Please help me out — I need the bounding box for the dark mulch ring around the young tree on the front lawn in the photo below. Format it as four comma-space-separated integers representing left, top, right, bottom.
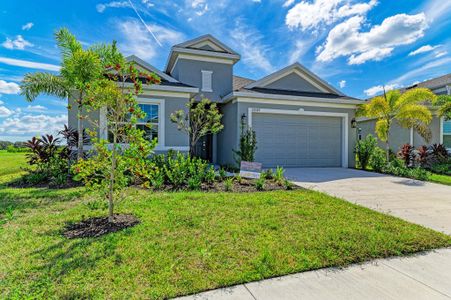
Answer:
63, 215, 139, 239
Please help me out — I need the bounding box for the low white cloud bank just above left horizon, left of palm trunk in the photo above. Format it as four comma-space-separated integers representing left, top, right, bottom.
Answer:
0, 114, 67, 136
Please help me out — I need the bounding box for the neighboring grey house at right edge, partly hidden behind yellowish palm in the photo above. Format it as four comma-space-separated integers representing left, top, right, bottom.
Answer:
357, 74, 451, 152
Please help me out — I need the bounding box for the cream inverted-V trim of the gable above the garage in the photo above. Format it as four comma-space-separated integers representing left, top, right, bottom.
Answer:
245, 62, 345, 96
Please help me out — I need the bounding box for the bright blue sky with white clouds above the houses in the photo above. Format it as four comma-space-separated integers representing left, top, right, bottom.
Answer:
0, 0, 451, 141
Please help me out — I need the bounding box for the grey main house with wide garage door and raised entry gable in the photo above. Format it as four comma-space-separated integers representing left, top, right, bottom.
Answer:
69, 35, 361, 167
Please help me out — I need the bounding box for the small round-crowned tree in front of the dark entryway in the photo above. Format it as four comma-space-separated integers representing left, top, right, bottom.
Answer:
171, 98, 224, 157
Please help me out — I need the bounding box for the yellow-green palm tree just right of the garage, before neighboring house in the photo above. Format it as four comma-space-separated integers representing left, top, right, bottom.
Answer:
357, 88, 437, 161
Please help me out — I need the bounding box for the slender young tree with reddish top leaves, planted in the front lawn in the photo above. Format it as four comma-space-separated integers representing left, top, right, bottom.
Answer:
73, 43, 160, 222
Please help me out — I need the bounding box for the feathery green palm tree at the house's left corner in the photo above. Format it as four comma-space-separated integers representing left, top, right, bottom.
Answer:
20, 28, 103, 160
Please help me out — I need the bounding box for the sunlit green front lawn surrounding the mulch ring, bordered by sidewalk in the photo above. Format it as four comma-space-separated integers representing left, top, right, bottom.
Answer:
0, 154, 451, 299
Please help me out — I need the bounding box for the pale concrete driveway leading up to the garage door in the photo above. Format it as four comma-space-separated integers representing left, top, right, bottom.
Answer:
285, 168, 451, 234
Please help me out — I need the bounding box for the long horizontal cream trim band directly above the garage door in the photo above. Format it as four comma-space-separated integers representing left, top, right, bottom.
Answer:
232, 97, 362, 109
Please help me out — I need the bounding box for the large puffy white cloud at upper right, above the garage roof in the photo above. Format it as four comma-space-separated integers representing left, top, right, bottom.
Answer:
317, 13, 428, 64
